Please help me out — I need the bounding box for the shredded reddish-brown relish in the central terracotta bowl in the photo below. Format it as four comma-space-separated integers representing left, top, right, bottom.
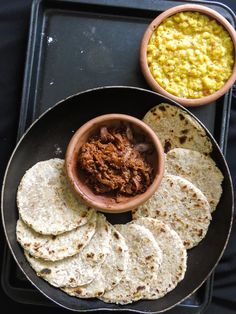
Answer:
78, 126, 153, 197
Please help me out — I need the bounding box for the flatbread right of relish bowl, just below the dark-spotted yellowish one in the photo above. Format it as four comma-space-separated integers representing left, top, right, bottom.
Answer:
166, 148, 224, 212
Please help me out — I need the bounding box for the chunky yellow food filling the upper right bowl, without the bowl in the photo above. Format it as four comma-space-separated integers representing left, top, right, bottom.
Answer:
147, 12, 234, 98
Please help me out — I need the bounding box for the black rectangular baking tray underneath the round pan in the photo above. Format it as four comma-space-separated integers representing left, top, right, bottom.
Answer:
1, 0, 236, 314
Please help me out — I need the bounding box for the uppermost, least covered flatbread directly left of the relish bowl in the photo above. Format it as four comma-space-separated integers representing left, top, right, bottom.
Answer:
17, 158, 94, 235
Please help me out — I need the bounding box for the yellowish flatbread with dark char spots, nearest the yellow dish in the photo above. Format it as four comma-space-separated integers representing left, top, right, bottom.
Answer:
143, 103, 212, 154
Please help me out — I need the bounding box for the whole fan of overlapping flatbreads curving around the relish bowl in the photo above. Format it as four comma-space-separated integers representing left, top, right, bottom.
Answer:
16, 104, 223, 304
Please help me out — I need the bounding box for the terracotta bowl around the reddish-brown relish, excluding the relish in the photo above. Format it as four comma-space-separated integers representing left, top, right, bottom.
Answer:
65, 114, 164, 213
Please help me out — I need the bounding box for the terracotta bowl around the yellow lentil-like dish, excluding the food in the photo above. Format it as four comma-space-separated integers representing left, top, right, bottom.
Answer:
140, 4, 236, 107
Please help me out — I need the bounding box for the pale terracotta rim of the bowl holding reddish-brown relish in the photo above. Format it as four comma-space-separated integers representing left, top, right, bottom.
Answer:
65, 113, 165, 213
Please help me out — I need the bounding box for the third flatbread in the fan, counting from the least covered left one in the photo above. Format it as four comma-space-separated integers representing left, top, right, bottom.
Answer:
25, 214, 110, 287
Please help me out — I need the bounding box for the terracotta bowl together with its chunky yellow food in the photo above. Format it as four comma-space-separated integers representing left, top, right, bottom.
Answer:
140, 4, 236, 106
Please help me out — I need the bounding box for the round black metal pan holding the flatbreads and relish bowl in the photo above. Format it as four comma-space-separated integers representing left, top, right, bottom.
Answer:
2, 87, 233, 313
